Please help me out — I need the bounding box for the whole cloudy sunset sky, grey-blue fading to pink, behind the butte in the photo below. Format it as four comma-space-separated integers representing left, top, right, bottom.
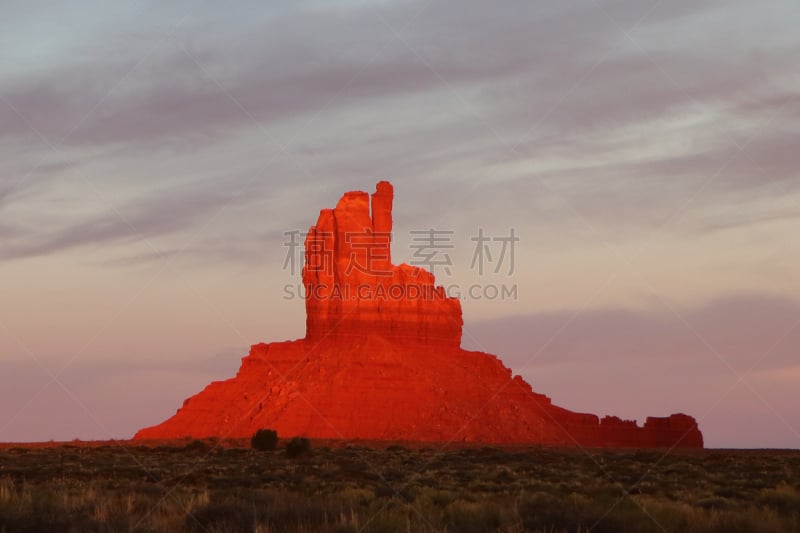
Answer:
0, 0, 800, 448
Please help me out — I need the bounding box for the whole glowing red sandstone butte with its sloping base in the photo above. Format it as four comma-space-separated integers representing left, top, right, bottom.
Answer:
134, 181, 703, 448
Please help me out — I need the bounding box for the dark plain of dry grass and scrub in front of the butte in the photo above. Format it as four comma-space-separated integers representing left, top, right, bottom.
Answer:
0, 442, 800, 533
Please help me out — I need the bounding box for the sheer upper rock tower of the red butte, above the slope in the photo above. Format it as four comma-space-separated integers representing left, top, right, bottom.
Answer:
303, 181, 463, 348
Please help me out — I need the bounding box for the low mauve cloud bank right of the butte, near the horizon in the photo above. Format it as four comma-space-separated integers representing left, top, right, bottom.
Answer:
465, 294, 800, 373
